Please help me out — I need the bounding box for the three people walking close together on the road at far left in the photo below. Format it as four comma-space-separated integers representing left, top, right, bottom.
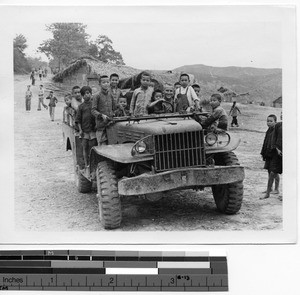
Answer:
25, 85, 58, 121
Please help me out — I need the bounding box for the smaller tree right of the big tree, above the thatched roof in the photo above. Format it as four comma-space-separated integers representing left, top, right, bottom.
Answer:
88, 35, 125, 65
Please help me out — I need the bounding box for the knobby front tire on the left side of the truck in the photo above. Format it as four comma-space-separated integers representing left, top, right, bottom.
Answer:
96, 161, 122, 229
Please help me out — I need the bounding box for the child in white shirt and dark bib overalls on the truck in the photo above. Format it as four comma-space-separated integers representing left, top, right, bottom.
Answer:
174, 74, 200, 112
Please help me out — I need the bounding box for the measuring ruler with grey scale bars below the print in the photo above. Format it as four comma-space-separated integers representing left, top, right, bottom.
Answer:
0, 250, 228, 292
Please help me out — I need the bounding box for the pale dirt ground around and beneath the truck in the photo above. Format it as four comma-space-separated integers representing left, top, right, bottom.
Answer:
14, 76, 282, 232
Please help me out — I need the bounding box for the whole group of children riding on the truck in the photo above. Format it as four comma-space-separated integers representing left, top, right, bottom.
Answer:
64, 72, 234, 169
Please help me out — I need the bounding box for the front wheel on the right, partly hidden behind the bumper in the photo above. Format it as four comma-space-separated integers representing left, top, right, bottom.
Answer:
212, 152, 244, 214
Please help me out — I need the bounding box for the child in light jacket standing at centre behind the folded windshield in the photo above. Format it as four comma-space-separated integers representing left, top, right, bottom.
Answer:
130, 72, 153, 116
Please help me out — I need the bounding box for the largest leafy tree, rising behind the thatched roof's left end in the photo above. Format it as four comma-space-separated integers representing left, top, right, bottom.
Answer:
38, 23, 89, 69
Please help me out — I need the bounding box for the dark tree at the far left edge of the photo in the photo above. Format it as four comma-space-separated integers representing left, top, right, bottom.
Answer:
13, 34, 31, 74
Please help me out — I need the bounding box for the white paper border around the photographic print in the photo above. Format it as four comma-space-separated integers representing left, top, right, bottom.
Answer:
0, 5, 297, 244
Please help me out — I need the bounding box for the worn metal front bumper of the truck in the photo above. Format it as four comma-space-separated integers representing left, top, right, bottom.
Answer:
118, 166, 245, 196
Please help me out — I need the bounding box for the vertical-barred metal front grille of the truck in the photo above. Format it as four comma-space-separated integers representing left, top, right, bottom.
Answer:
154, 130, 205, 172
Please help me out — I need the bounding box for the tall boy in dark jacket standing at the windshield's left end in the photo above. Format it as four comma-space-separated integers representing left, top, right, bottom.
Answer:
92, 75, 116, 146
